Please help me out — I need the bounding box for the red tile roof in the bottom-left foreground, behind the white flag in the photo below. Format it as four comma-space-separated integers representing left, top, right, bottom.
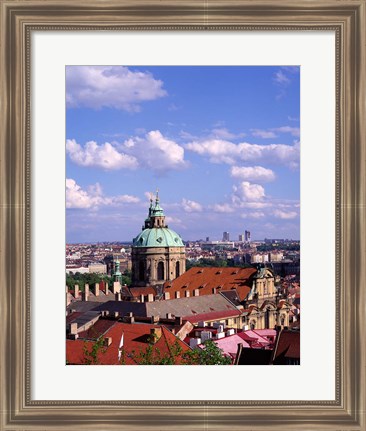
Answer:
66, 322, 190, 365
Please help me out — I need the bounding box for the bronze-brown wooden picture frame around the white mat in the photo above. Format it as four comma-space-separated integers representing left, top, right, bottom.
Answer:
0, 0, 366, 431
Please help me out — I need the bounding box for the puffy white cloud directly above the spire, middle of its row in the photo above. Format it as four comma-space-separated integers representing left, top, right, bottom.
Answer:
121, 130, 187, 172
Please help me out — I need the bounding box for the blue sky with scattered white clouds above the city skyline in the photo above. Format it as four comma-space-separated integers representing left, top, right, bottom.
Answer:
66, 66, 300, 243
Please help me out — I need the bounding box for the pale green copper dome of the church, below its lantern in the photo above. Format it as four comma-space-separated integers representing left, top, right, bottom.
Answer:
133, 227, 184, 247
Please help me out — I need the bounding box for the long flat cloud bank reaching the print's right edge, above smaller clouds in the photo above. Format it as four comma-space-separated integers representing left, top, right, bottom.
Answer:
185, 139, 300, 166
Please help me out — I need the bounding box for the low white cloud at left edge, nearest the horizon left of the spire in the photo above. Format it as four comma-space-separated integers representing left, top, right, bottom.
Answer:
66, 178, 140, 208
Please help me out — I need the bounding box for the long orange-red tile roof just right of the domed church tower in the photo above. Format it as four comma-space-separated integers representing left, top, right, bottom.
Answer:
164, 267, 257, 301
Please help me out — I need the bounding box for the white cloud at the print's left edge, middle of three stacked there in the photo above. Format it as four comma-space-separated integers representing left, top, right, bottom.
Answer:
66, 139, 138, 170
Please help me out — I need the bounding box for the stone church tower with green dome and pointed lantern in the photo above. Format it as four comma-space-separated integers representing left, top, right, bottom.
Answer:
132, 193, 186, 286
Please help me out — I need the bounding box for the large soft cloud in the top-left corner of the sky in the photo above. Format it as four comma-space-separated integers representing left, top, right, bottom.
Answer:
66, 66, 167, 112
